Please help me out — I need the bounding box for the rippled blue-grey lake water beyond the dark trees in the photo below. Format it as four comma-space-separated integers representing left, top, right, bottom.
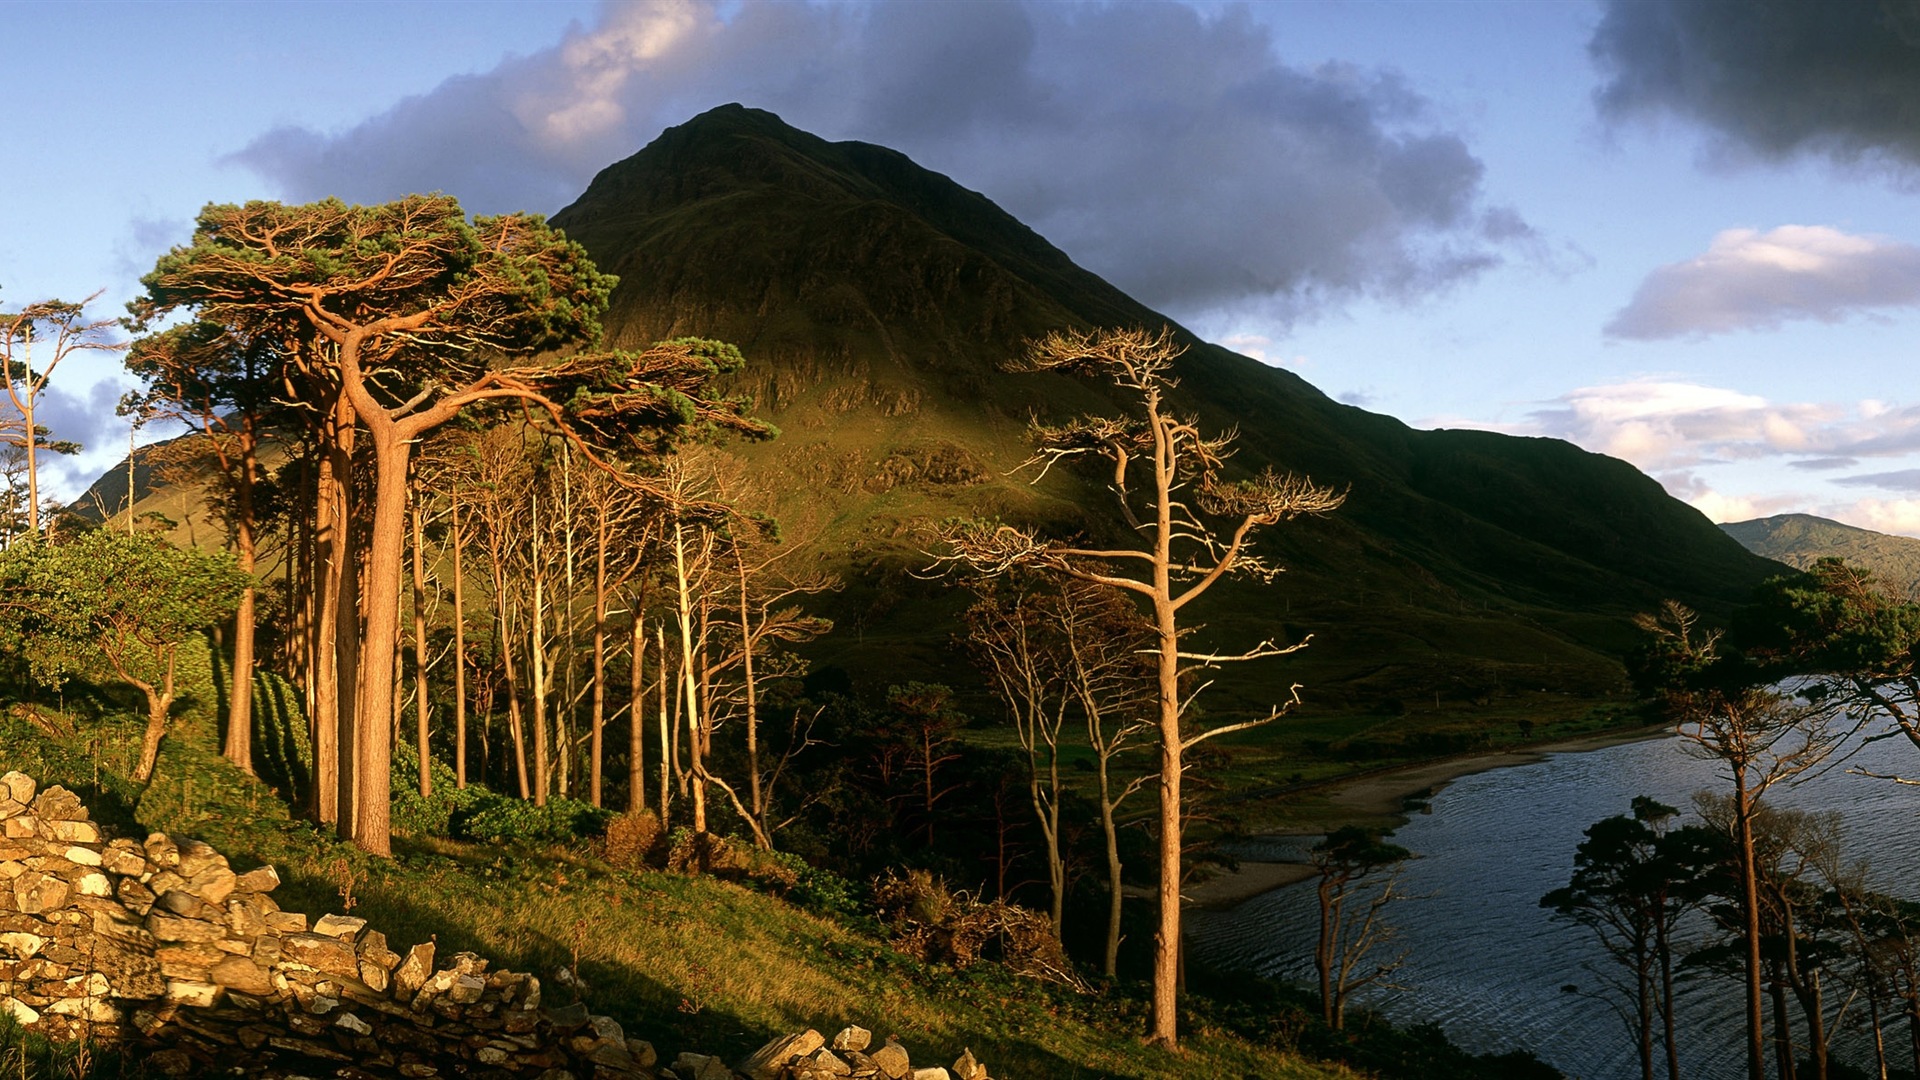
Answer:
1188, 722, 1920, 1080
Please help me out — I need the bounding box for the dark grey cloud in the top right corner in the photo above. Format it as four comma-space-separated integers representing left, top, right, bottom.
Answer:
1588, 0, 1920, 167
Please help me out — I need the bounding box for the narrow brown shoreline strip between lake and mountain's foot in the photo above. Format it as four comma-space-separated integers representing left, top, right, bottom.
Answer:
1183, 728, 1668, 909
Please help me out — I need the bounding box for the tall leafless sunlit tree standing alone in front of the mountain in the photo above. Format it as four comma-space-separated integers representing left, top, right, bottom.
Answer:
945, 331, 1344, 1047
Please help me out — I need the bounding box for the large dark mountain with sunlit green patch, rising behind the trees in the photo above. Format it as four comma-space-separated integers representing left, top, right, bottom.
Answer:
553, 106, 1780, 703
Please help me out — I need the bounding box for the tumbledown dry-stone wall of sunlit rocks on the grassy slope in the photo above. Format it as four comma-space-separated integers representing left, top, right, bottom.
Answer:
0, 773, 987, 1080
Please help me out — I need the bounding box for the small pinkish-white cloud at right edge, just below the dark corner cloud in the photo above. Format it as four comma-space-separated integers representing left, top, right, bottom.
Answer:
1605, 225, 1920, 340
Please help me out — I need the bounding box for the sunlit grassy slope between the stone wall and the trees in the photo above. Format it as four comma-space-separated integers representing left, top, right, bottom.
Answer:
0, 707, 1357, 1080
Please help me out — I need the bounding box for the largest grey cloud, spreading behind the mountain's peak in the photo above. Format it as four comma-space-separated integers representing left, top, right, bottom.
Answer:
234, 2, 1534, 317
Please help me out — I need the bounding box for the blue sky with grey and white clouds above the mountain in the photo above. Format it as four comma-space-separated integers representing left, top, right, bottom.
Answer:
0, 0, 1920, 536
